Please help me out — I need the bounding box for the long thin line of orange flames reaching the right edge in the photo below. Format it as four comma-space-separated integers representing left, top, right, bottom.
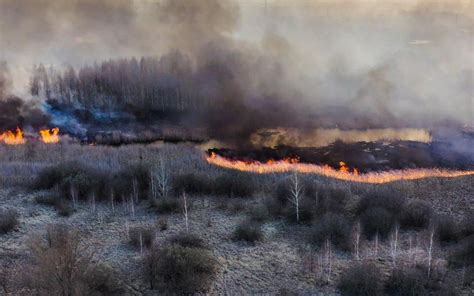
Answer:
207, 153, 474, 184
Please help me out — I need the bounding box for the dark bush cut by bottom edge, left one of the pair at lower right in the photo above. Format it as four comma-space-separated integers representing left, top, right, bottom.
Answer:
337, 263, 382, 296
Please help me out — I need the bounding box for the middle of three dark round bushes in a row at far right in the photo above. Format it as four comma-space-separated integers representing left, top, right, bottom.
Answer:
400, 200, 433, 229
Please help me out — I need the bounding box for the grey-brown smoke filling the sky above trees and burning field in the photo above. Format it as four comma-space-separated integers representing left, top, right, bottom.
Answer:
0, 0, 474, 140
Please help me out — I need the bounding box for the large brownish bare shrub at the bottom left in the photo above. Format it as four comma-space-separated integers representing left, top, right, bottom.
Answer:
28, 224, 123, 295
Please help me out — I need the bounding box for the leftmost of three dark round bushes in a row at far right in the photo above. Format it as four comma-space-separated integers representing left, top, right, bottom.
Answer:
361, 207, 395, 238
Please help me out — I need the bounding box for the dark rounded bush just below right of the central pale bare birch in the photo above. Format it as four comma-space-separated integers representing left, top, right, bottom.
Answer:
310, 213, 351, 250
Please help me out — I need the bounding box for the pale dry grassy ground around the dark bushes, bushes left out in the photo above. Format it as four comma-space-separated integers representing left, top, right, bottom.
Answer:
0, 144, 474, 295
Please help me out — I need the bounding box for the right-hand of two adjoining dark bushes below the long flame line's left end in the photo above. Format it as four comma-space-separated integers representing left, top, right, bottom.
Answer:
214, 173, 255, 197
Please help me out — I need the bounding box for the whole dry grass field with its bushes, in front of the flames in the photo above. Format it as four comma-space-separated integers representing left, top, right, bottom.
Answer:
0, 143, 474, 295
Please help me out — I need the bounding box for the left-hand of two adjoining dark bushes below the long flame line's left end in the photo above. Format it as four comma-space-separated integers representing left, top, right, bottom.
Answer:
172, 174, 212, 195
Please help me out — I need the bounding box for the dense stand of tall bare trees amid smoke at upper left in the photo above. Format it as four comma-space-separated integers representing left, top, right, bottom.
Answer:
30, 52, 210, 112
